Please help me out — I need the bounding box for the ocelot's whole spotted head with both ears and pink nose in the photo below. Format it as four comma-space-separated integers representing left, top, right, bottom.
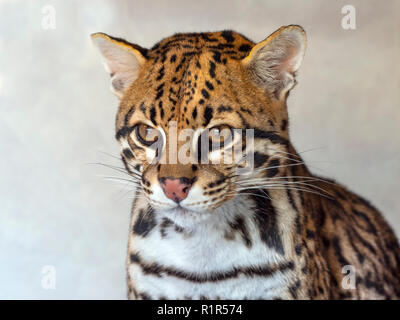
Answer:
92, 25, 306, 225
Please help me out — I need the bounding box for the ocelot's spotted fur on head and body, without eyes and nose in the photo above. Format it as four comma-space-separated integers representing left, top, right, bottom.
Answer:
93, 26, 400, 299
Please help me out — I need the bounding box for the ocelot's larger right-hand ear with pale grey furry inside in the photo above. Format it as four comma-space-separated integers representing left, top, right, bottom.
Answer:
242, 25, 307, 99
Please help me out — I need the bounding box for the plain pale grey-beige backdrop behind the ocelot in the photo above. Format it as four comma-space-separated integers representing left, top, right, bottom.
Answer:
0, 0, 400, 299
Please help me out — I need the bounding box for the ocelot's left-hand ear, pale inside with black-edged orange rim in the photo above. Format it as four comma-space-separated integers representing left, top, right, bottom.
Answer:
91, 33, 147, 99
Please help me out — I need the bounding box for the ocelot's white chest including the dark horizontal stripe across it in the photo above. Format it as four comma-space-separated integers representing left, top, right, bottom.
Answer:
128, 199, 294, 299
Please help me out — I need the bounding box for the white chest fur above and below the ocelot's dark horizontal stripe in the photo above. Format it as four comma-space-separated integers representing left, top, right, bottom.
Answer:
128, 197, 293, 299
